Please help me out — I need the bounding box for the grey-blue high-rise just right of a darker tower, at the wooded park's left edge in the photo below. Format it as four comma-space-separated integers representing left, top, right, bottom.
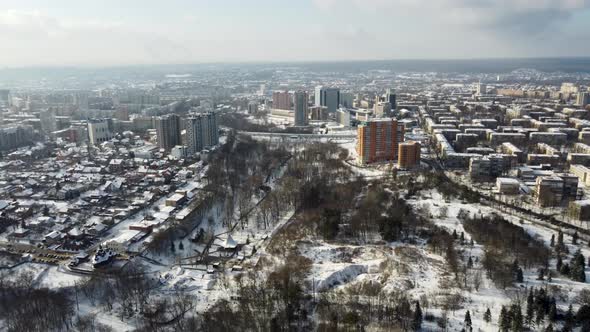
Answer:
186, 112, 219, 154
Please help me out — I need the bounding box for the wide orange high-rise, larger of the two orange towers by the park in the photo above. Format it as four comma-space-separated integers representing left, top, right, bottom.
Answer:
356, 118, 404, 164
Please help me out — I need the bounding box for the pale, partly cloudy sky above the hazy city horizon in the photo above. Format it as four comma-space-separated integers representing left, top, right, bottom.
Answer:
0, 0, 590, 68
